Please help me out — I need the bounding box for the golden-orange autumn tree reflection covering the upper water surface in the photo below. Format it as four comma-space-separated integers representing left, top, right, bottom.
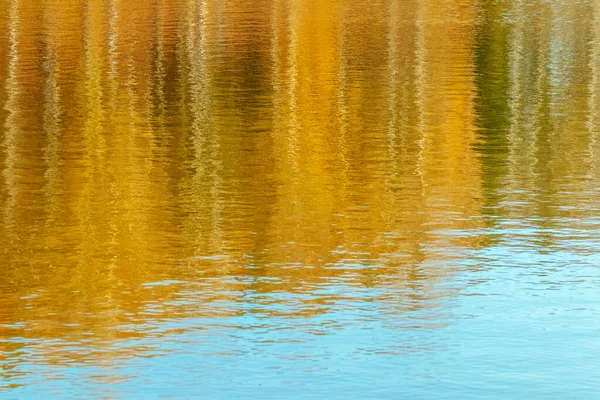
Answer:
0, 0, 600, 388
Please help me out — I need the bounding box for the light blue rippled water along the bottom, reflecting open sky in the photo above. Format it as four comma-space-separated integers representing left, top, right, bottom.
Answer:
5, 223, 600, 399
